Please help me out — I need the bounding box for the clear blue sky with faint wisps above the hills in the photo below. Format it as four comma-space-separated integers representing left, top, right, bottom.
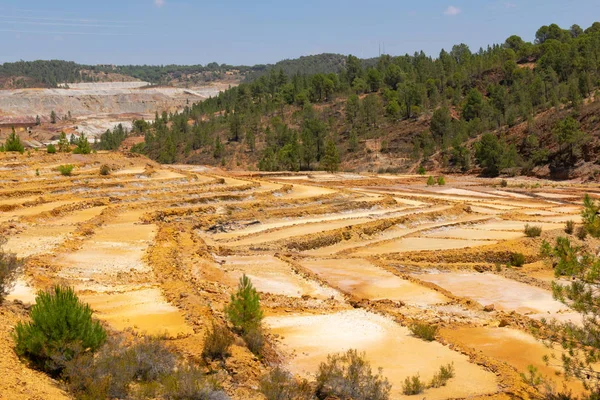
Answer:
0, 0, 600, 65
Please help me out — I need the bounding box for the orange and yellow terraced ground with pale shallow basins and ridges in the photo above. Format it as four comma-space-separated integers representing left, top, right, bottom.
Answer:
0, 152, 598, 399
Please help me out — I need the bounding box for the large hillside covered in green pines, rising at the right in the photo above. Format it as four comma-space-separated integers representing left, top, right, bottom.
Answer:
116, 23, 600, 178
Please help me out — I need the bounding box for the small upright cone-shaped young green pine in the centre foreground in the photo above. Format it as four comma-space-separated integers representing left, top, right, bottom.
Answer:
225, 274, 263, 333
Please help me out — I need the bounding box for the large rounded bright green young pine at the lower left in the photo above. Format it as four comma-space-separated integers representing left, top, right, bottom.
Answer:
14, 286, 106, 376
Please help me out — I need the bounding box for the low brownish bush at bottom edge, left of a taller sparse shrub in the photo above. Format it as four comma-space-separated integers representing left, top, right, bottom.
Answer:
259, 367, 313, 400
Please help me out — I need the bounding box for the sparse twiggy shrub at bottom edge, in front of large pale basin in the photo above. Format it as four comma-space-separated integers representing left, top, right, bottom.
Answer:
316, 349, 392, 400
